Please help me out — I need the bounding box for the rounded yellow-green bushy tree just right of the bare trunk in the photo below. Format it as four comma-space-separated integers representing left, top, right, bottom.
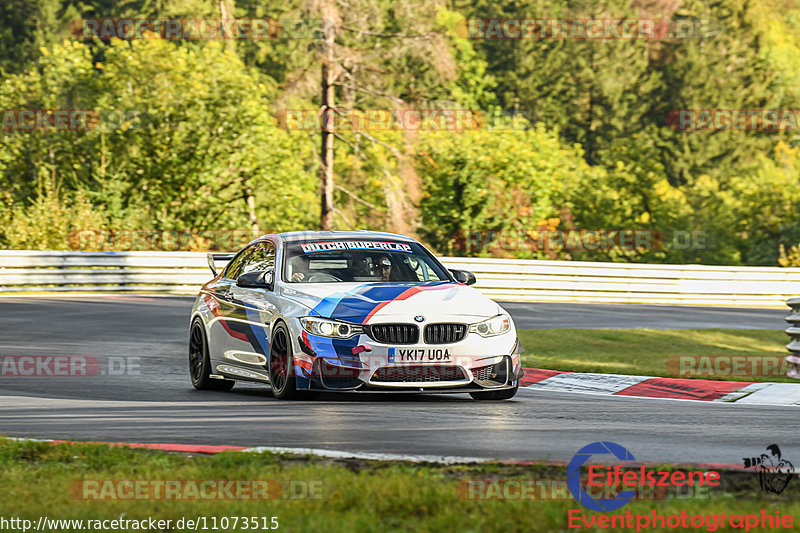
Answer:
417, 119, 603, 258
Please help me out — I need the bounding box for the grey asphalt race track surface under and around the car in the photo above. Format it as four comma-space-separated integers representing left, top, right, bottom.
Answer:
0, 297, 800, 463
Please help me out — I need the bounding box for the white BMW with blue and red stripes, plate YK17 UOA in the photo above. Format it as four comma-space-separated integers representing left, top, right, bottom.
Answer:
189, 231, 522, 400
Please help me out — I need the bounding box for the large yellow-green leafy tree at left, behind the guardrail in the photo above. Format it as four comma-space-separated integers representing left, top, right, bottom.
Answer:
0, 39, 314, 249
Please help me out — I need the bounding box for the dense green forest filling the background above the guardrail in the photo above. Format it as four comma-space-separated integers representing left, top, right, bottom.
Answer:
0, 0, 800, 266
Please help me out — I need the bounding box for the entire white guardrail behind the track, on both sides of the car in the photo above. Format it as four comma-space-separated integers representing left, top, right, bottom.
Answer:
0, 250, 800, 307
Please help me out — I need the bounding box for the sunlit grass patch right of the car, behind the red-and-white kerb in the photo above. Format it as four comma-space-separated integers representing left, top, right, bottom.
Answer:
518, 329, 797, 383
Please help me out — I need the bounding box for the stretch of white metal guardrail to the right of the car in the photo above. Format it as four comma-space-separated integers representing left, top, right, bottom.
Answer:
443, 257, 800, 307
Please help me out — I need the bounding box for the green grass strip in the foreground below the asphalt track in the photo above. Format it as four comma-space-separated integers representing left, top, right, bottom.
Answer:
0, 439, 800, 533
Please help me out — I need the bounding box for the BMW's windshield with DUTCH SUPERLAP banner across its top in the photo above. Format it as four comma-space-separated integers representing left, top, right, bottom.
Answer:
283, 239, 450, 283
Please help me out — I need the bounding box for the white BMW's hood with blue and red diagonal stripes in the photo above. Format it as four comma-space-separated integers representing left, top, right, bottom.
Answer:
281, 282, 501, 324
